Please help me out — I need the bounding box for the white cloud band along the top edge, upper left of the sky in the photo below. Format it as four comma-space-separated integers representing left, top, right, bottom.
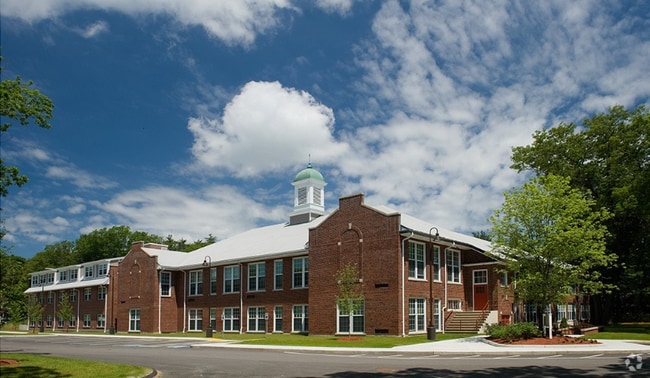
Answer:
2, 0, 295, 46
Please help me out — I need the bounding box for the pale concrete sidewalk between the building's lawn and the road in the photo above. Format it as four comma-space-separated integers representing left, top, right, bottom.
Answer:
192, 336, 650, 356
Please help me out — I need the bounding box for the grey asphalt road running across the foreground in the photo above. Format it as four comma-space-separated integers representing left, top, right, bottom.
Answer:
0, 335, 636, 378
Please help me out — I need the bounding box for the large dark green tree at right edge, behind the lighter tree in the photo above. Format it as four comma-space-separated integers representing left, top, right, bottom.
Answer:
512, 106, 650, 324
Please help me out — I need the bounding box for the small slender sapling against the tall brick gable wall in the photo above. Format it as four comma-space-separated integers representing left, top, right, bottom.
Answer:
334, 264, 364, 338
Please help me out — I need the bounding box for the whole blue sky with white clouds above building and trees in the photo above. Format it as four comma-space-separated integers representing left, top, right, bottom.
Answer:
0, 0, 650, 257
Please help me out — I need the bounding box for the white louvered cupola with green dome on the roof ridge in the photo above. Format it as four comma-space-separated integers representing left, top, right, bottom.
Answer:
289, 162, 327, 224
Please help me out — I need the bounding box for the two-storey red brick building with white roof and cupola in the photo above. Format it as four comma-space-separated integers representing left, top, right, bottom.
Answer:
27, 164, 513, 335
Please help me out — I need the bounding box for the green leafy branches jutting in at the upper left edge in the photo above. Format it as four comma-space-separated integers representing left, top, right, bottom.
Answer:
0, 57, 54, 197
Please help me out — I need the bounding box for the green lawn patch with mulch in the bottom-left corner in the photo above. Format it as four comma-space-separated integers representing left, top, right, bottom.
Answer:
0, 353, 151, 378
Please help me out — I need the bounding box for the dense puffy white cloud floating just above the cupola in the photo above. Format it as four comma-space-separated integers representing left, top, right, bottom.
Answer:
188, 82, 347, 177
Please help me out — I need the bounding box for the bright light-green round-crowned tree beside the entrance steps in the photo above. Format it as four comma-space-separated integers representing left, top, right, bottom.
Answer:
489, 175, 616, 325
